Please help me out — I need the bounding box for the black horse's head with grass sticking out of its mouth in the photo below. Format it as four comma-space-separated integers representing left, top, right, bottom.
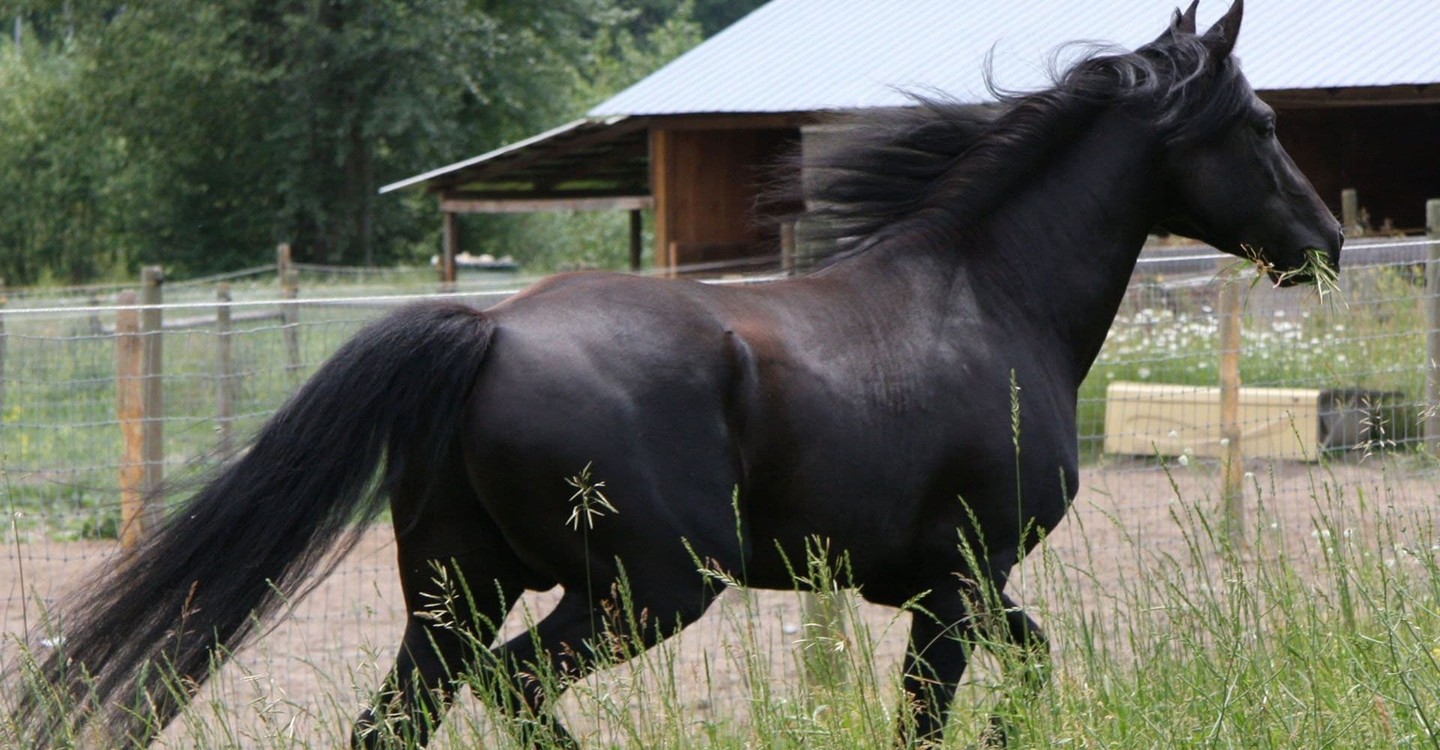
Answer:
1139, 0, 1344, 285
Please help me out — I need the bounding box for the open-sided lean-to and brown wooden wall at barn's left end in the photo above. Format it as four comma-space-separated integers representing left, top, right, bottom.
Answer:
380, 112, 814, 281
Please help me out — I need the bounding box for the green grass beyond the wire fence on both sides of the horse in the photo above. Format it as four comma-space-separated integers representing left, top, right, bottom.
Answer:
0, 260, 1426, 538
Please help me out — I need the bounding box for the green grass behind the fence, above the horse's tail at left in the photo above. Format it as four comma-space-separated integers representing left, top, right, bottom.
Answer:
0, 269, 535, 538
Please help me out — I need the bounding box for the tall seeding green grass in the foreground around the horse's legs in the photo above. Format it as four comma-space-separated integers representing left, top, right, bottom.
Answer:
11, 452, 1440, 749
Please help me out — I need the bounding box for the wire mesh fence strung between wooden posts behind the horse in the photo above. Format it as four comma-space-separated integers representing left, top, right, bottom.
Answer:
0, 239, 1440, 737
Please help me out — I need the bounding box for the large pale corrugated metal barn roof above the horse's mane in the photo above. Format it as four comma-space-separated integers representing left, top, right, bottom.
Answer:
589, 0, 1440, 117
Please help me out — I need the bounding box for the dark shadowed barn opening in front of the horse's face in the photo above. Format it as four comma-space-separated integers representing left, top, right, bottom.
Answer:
1279, 104, 1440, 232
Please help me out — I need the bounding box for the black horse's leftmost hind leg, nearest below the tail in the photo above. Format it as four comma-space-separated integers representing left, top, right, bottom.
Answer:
351, 462, 523, 749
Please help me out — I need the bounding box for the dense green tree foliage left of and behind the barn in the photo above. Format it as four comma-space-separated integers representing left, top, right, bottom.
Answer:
0, 0, 714, 284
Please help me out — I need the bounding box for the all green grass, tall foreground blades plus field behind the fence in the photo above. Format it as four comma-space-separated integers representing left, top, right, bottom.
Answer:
0, 257, 1440, 750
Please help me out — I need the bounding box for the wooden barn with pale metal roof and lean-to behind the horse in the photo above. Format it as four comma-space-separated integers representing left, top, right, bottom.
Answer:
382, 0, 1440, 279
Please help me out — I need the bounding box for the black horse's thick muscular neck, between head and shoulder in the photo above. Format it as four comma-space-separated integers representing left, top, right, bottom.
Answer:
819, 114, 1156, 387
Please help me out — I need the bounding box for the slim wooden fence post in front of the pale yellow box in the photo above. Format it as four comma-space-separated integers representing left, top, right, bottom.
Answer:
1217, 259, 1246, 548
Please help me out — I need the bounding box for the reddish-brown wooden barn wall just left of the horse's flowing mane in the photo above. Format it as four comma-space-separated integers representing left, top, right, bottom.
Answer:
651, 127, 799, 268
